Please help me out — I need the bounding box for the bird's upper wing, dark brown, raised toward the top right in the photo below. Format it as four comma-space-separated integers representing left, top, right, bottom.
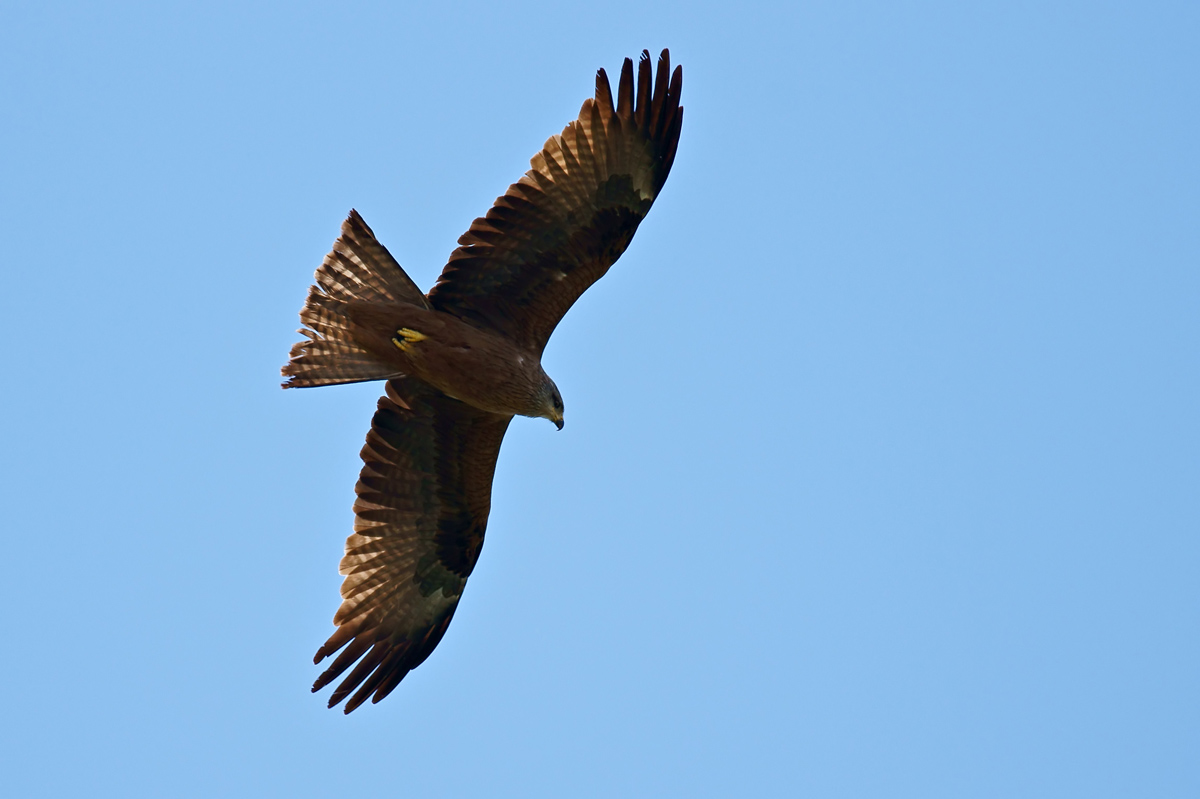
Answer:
428, 50, 683, 354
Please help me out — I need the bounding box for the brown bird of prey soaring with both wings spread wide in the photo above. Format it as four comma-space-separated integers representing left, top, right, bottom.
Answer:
283, 50, 683, 713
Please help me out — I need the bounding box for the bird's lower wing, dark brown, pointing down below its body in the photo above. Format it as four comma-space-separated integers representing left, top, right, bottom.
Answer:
312, 379, 512, 713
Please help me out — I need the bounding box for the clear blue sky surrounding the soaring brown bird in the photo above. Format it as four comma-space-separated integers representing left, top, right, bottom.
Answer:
0, 0, 1200, 799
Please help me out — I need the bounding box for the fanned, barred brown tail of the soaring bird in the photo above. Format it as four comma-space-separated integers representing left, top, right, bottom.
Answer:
282, 210, 428, 389
